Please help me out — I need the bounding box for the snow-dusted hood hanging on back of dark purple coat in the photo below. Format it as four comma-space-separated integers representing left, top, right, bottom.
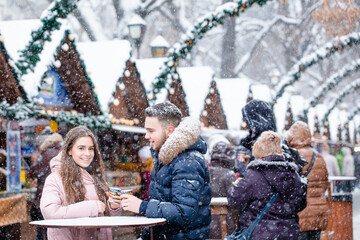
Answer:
247, 155, 300, 196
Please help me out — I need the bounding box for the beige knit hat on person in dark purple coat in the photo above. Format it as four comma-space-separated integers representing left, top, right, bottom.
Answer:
252, 131, 283, 159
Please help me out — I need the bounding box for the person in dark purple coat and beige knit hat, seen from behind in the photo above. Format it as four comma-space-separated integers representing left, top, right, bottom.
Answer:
227, 131, 306, 240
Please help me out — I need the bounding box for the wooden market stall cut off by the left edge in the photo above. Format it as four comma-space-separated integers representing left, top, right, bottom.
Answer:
0, 23, 32, 239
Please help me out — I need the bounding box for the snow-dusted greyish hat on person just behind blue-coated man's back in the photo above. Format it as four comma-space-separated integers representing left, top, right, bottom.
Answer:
211, 142, 235, 168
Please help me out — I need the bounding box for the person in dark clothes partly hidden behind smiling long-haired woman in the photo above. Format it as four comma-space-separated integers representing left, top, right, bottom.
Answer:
30, 133, 63, 239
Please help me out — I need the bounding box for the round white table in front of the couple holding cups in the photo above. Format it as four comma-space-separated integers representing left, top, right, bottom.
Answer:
30, 216, 166, 240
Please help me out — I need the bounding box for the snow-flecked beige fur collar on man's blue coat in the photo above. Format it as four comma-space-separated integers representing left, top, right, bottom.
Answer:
159, 117, 201, 165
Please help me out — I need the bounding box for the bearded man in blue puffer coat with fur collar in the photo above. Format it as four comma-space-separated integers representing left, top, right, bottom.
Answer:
121, 103, 212, 240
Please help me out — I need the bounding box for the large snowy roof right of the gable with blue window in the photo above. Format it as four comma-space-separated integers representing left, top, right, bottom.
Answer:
76, 39, 131, 112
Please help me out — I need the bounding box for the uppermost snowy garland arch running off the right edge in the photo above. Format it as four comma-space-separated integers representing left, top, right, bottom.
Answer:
272, 32, 360, 108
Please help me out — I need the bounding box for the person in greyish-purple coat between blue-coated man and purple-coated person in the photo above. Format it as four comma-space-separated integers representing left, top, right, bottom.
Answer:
209, 142, 237, 239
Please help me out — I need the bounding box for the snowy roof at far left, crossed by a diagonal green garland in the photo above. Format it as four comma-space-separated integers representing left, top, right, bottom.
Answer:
0, 19, 68, 98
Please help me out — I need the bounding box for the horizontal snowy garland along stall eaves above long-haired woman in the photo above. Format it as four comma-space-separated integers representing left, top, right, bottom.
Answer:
0, 98, 112, 130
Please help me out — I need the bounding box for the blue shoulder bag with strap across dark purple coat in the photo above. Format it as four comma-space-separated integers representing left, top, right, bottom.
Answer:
224, 192, 278, 240
